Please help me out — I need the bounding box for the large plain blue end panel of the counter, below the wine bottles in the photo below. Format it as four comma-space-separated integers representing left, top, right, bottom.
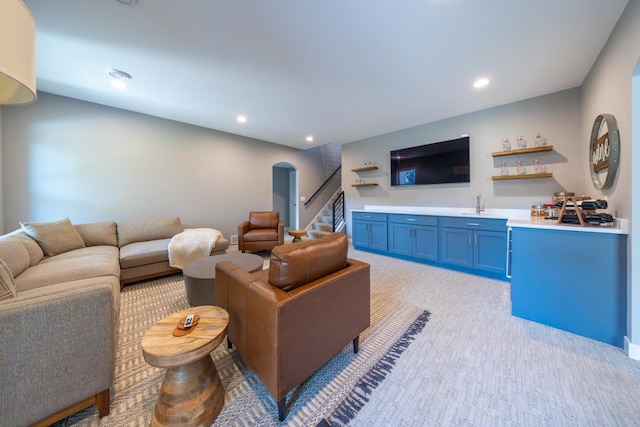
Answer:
511, 227, 627, 347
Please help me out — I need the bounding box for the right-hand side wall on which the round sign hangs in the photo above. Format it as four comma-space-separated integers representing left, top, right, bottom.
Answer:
580, 0, 640, 359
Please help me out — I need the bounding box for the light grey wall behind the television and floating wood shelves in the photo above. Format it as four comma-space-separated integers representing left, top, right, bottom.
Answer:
342, 89, 588, 226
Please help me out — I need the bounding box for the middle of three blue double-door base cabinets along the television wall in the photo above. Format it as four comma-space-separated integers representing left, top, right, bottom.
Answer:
387, 214, 438, 261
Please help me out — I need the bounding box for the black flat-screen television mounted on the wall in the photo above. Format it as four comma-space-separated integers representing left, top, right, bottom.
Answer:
390, 136, 471, 186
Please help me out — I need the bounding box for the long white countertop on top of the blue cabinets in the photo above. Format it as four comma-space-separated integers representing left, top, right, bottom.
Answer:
352, 205, 629, 234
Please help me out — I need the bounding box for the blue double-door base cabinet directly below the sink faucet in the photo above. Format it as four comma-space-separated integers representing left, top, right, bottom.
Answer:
440, 217, 507, 280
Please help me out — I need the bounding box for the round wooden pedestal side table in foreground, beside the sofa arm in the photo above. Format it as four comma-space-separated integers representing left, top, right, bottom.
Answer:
142, 305, 229, 426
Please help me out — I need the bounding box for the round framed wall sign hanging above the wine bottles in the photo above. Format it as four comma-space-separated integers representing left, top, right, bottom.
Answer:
589, 114, 620, 190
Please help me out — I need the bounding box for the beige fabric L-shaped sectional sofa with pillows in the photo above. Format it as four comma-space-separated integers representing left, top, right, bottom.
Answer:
0, 218, 229, 426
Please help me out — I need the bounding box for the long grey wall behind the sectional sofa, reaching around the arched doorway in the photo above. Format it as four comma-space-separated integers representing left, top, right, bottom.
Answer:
2, 93, 325, 237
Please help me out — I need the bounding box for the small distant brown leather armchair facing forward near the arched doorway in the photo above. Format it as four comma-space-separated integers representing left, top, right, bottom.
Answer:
238, 211, 284, 252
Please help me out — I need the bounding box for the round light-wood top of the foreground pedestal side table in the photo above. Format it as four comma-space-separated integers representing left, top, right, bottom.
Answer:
141, 305, 229, 368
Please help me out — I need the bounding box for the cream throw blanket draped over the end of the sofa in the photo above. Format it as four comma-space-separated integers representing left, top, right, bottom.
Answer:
169, 228, 222, 269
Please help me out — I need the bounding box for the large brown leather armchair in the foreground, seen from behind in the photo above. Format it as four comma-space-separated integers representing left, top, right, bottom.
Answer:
215, 234, 370, 421
